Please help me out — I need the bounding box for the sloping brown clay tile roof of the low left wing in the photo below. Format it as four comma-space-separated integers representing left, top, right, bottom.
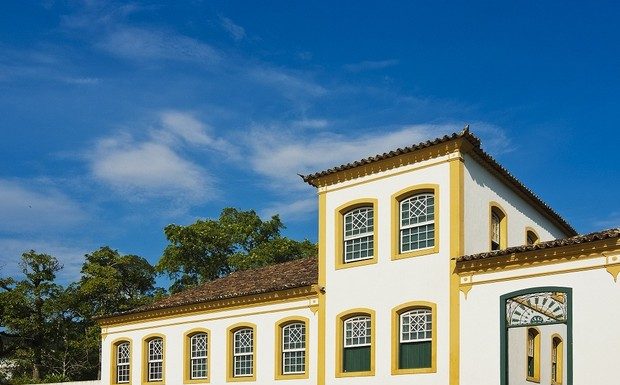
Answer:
106, 258, 319, 318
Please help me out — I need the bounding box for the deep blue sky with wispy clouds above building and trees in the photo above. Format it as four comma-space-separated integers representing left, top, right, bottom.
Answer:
0, 0, 620, 280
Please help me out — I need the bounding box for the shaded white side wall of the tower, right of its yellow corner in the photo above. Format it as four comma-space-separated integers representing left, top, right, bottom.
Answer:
464, 155, 566, 254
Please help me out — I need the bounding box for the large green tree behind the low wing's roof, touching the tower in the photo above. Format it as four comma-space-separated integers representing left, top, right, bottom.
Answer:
156, 207, 316, 292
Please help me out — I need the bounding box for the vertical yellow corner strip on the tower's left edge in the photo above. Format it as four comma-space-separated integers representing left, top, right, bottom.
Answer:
317, 194, 327, 385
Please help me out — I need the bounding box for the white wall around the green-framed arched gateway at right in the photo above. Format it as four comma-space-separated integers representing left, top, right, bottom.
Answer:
460, 257, 620, 385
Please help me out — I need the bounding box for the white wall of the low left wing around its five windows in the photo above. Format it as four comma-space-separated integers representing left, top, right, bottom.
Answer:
101, 300, 318, 385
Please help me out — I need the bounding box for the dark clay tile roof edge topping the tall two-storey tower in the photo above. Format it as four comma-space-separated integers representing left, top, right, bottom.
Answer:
299, 126, 577, 236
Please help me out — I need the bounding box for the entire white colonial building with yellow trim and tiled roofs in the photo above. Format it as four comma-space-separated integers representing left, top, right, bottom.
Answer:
100, 129, 620, 385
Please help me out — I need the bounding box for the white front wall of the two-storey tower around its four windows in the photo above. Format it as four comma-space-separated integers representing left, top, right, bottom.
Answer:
326, 158, 450, 385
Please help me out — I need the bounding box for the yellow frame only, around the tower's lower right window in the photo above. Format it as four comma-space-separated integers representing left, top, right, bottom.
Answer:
392, 301, 437, 375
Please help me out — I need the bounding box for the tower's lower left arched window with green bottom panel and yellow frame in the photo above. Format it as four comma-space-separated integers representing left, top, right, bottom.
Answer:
336, 309, 375, 377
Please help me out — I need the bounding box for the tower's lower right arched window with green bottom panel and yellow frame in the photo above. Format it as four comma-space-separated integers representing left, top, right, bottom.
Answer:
392, 301, 437, 374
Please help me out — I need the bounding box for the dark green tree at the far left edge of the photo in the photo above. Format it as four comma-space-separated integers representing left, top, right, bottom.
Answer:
0, 250, 63, 381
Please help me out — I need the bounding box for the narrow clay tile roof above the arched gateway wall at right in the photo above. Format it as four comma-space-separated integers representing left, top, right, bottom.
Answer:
457, 228, 620, 262
